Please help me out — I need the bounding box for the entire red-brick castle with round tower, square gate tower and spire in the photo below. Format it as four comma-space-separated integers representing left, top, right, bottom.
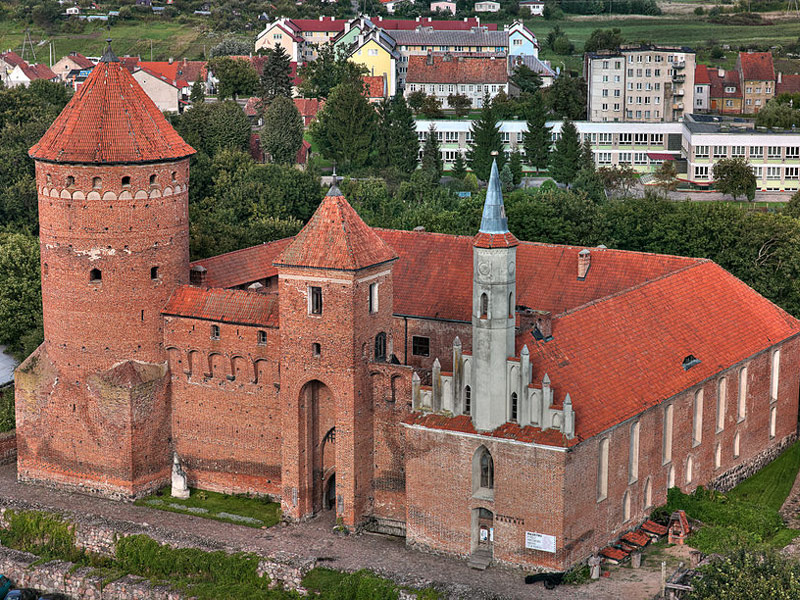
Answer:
16, 43, 800, 569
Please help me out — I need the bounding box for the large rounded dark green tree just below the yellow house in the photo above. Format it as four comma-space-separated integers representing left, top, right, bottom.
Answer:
311, 81, 377, 169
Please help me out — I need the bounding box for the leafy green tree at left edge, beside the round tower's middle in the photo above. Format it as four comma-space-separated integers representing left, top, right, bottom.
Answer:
0, 233, 42, 354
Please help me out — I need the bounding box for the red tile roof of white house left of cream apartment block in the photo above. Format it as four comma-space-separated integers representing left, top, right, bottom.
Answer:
406, 54, 508, 84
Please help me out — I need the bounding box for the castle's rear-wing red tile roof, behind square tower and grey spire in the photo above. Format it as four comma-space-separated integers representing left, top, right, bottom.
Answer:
196, 229, 698, 322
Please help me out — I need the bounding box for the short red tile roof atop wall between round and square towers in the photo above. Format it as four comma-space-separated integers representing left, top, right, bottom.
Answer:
161, 285, 278, 327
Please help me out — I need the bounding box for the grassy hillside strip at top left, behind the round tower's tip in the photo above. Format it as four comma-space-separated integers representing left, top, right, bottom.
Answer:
0, 18, 242, 62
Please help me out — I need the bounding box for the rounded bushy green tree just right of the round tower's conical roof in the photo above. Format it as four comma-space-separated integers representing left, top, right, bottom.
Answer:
173, 100, 251, 157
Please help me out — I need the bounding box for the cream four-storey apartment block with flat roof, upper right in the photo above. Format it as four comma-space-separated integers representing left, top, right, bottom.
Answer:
584, 46, 695, 123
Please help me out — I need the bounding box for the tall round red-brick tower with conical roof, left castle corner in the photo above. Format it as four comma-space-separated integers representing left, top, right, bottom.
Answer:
17, 46, 194, 496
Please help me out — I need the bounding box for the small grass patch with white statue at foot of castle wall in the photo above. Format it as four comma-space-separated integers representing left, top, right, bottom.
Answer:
134, 487, 281, 528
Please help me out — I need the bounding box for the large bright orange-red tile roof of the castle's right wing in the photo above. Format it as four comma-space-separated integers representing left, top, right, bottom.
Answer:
517, 257, 800, 439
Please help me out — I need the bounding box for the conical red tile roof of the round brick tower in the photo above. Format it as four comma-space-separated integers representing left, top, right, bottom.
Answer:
28, 41, 195, 164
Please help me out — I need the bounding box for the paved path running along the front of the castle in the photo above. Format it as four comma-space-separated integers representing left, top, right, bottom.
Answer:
0, 465, 659, 600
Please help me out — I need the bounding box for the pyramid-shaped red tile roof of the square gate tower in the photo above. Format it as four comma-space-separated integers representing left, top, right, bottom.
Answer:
274, 183, 397, 271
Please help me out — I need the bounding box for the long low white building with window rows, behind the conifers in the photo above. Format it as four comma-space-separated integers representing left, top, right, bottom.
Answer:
417, 115, 800, 192
